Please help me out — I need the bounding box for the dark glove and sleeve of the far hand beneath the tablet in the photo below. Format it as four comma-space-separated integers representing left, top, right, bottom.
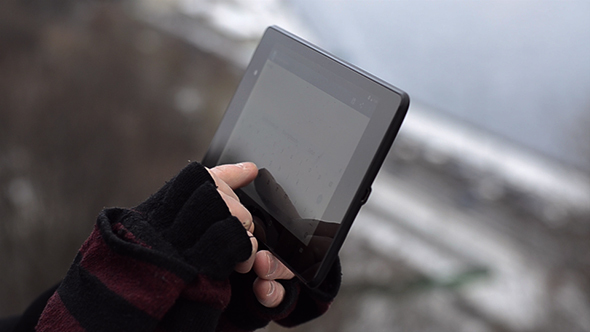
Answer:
217, 260, 342, 332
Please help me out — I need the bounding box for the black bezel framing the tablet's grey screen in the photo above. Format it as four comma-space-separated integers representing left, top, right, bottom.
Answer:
202, 26, 409, 287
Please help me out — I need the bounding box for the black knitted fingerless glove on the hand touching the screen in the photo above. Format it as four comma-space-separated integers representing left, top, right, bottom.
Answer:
109, 163, 252, 280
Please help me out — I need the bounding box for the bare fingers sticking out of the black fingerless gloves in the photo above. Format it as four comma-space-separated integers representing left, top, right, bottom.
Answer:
209, 163, 295, 308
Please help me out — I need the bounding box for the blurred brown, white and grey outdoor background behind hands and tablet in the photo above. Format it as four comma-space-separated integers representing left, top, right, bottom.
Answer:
0, 0, 590, 332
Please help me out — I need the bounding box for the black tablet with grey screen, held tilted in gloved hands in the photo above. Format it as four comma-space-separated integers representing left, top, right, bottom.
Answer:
203, 27, 409, 287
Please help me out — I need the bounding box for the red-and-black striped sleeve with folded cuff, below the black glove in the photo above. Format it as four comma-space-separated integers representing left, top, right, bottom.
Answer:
37, 215, 196, 331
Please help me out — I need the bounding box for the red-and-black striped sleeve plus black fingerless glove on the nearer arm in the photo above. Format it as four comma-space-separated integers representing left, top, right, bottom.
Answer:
36, 163, 252, 332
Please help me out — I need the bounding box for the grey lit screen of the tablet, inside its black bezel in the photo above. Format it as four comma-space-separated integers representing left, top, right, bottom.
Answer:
219, 48, 377, 245
